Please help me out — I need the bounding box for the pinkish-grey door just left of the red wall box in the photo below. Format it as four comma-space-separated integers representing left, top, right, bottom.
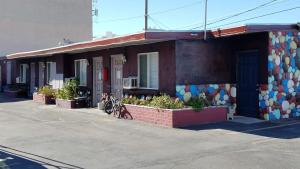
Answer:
93, 57, 103, 106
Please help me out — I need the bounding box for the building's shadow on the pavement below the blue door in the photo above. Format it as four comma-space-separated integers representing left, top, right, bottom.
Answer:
181, 119, 300, 139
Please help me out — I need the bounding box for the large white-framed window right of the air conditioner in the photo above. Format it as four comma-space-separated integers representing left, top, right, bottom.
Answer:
138, 52, 159, 89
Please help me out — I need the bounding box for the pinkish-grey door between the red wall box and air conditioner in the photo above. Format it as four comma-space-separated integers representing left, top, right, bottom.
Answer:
111, 55, 123, 99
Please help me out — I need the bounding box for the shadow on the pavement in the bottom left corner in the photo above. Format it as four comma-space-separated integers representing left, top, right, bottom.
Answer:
0, 145, 84, 169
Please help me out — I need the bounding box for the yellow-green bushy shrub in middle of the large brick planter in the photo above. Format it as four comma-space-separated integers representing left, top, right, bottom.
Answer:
149, 94, 184, 109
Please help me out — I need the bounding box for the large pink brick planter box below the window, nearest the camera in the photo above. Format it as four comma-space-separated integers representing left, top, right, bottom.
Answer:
125, 104, 228, 127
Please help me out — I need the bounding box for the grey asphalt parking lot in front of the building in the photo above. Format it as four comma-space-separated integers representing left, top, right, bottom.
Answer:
0, 95, 300, 169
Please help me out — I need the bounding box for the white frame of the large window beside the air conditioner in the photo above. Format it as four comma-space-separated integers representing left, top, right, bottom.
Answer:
137, 52, 159, 90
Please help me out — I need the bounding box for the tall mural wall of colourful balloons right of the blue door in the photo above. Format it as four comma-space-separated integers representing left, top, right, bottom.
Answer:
259, 32, 300, 120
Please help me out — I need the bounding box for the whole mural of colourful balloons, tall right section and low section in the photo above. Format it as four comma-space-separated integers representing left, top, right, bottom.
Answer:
176, 32, 300, 120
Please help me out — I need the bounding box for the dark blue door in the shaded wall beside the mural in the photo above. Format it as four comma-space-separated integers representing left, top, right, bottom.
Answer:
237, 51, 259, 117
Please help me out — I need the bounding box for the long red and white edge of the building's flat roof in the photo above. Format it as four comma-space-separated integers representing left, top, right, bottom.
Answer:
6, 24, 299, 59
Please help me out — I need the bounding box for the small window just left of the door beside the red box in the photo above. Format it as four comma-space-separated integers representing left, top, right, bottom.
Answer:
75, 59, 87, 86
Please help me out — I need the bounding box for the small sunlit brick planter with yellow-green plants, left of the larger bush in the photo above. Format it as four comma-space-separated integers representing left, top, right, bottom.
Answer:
33, 86, 55, 104
